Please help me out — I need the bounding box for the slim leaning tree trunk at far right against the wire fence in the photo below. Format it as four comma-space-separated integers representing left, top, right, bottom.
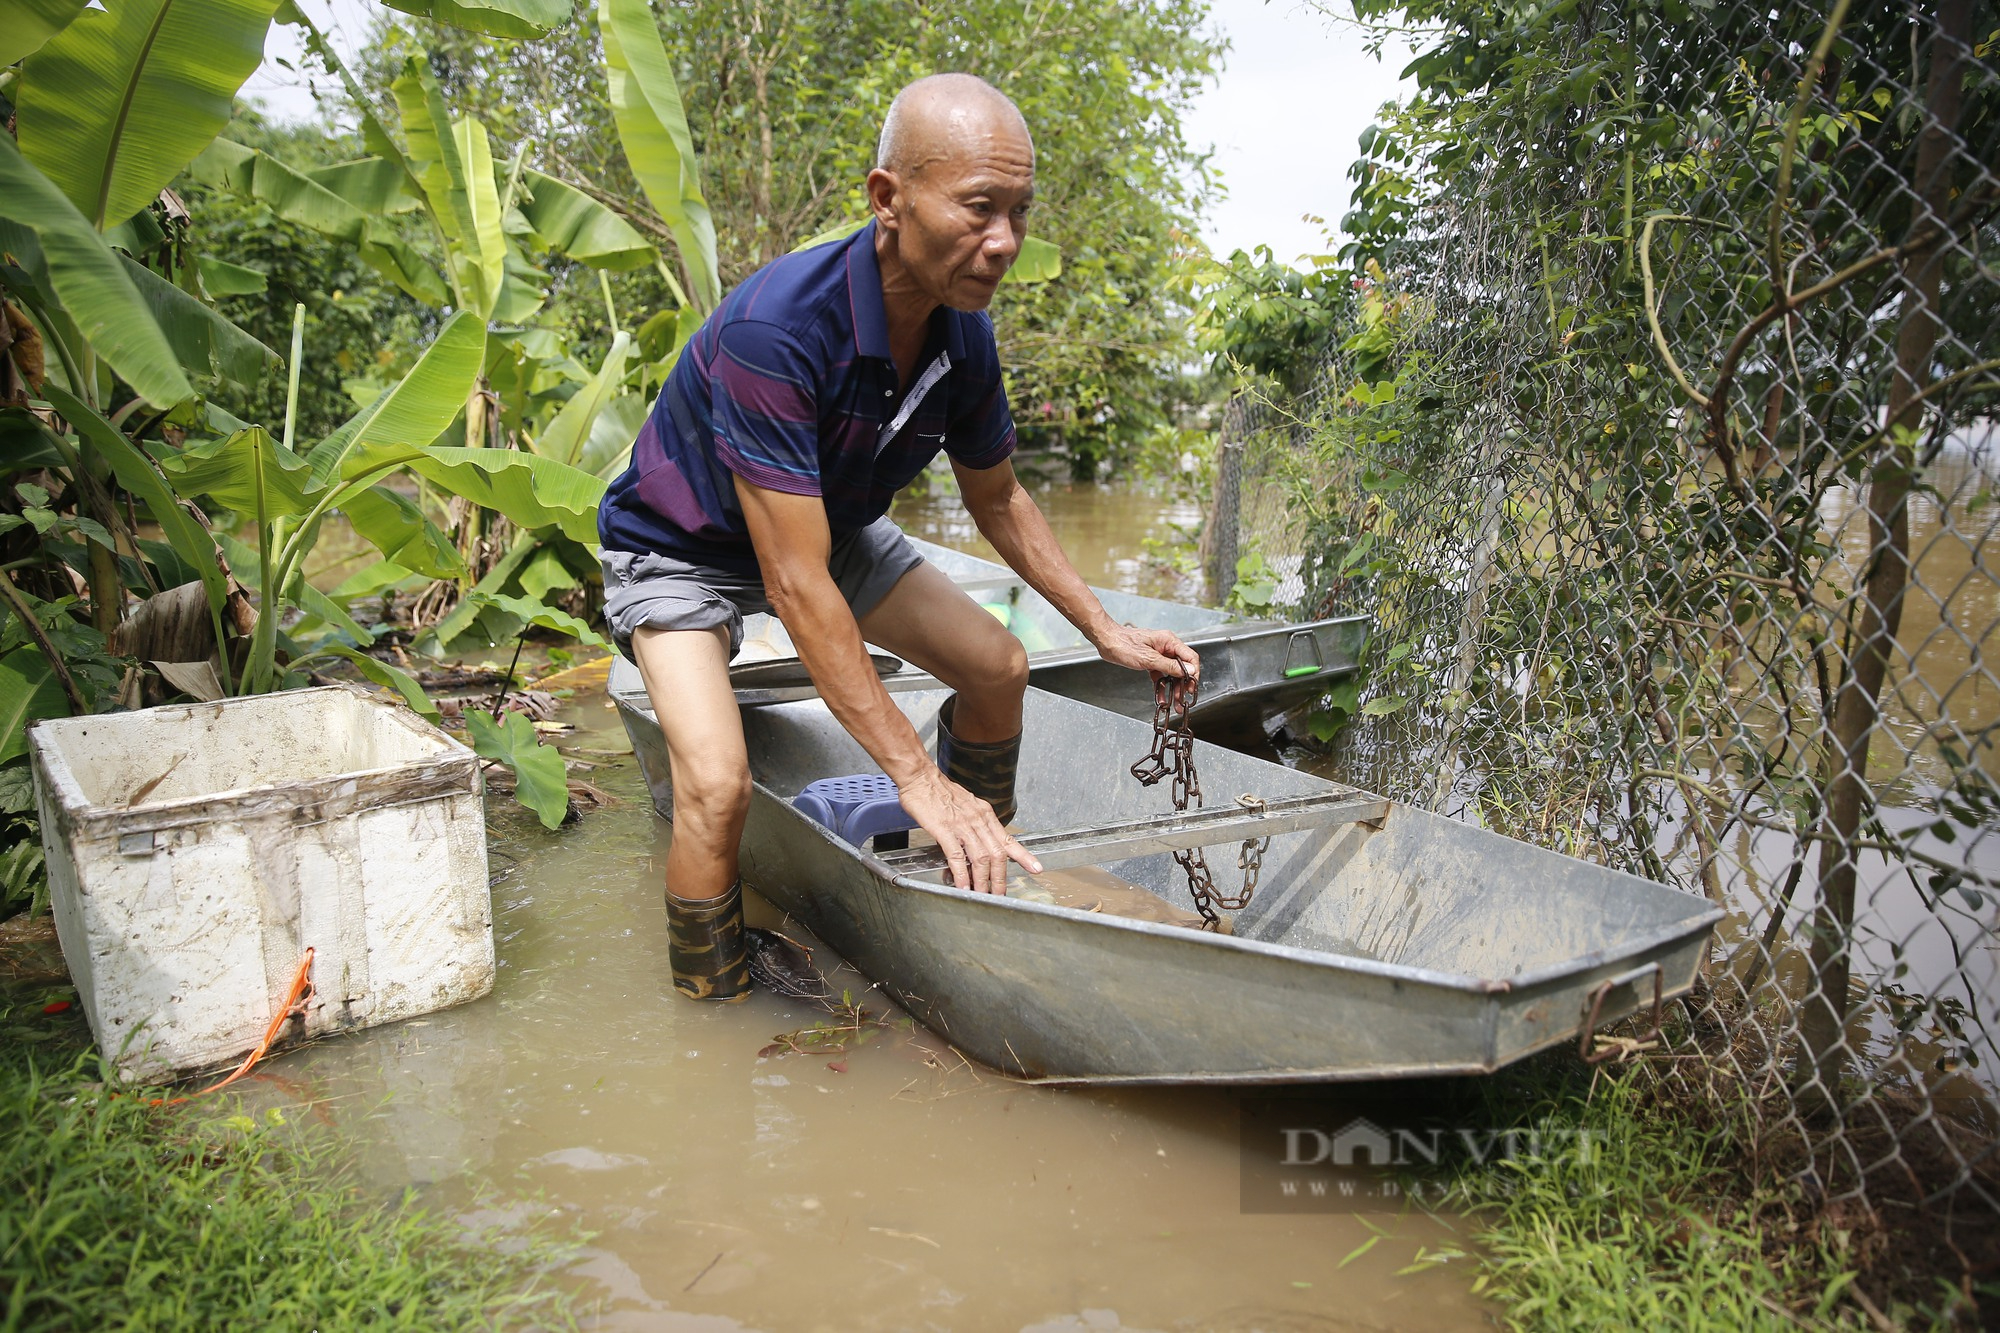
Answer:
1798, 0, 1972, 1111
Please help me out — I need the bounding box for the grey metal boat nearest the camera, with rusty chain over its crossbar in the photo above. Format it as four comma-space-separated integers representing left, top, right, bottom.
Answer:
610, 660, 1722, 1083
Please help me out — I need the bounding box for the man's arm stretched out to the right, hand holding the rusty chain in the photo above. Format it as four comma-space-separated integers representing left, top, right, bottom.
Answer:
952, 458, 1202, 679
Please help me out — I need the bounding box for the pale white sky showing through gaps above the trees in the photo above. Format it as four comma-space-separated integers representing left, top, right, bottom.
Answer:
244, 0, 1410, 262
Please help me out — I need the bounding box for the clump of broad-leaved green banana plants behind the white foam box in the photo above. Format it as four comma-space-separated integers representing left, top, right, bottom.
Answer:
0, 0, 624, 780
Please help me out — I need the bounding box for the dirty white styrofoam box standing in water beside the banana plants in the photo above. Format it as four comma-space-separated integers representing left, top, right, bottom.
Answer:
28, 687, 494, 1079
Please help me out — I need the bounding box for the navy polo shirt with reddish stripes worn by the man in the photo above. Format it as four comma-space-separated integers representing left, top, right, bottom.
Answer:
598, 222, 1014, 574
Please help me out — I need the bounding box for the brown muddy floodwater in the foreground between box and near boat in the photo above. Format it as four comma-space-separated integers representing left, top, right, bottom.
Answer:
254, 480, 1490, 1333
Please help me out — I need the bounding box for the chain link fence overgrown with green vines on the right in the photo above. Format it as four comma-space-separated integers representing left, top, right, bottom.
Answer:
1204, 0, 2000, 1281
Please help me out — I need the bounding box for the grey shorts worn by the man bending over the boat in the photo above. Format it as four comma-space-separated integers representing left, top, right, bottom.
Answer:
604, 516, 924, 658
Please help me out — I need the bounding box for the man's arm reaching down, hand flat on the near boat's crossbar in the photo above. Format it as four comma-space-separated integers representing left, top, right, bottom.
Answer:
734, 476, 1048, 893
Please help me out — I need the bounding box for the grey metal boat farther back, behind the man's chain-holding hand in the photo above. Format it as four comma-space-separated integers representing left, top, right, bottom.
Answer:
740, 538, 1368, 743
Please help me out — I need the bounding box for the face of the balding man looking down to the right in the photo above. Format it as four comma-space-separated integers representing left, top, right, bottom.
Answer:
880, 116, 1034, 310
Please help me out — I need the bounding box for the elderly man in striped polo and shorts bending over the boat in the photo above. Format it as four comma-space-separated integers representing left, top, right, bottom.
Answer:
598, 74, 1200, 1001
